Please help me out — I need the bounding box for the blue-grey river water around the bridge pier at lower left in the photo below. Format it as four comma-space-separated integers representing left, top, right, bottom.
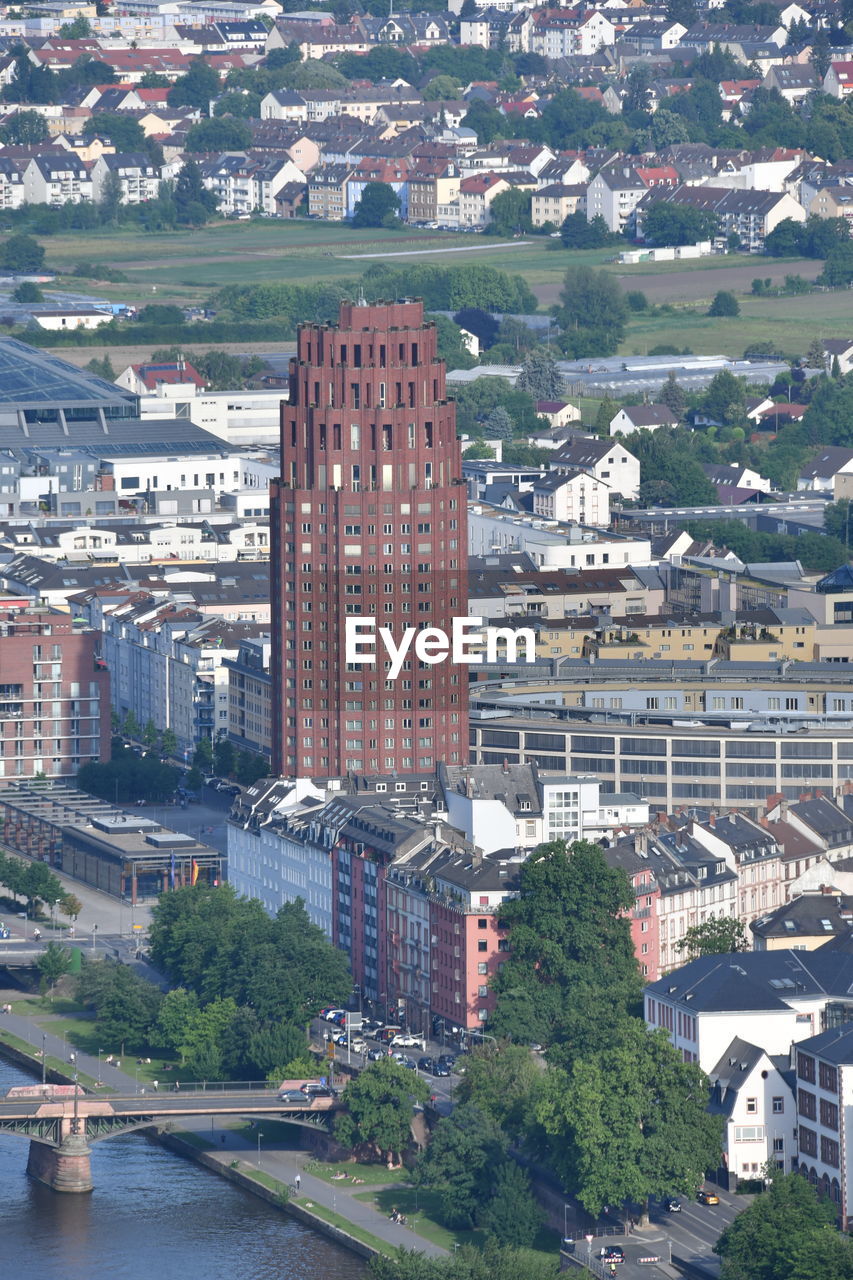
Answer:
0, 1060, 368, 1280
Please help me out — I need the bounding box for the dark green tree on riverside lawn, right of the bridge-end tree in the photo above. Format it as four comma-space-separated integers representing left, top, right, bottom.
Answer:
415, 1102, 507, 1230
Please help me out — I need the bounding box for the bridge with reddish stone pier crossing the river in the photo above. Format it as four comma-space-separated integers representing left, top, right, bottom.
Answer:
0, 1080, 341, 1192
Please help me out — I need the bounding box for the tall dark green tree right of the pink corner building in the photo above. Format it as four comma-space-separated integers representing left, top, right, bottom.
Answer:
492, 841, 640, 1051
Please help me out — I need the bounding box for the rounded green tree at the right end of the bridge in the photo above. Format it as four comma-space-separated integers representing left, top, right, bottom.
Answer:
334, 1057, 429, 1169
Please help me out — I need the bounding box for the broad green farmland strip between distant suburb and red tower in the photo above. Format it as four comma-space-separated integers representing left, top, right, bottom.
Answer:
33, 219, 853, 362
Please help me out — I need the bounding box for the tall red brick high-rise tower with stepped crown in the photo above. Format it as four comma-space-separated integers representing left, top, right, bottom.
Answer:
270, 301, 467, 777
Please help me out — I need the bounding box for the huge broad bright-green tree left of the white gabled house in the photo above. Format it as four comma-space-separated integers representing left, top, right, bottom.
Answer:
535, 1018, 722, 1213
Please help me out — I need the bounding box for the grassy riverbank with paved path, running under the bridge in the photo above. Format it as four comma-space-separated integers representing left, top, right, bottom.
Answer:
0, 992, 448, 1258
